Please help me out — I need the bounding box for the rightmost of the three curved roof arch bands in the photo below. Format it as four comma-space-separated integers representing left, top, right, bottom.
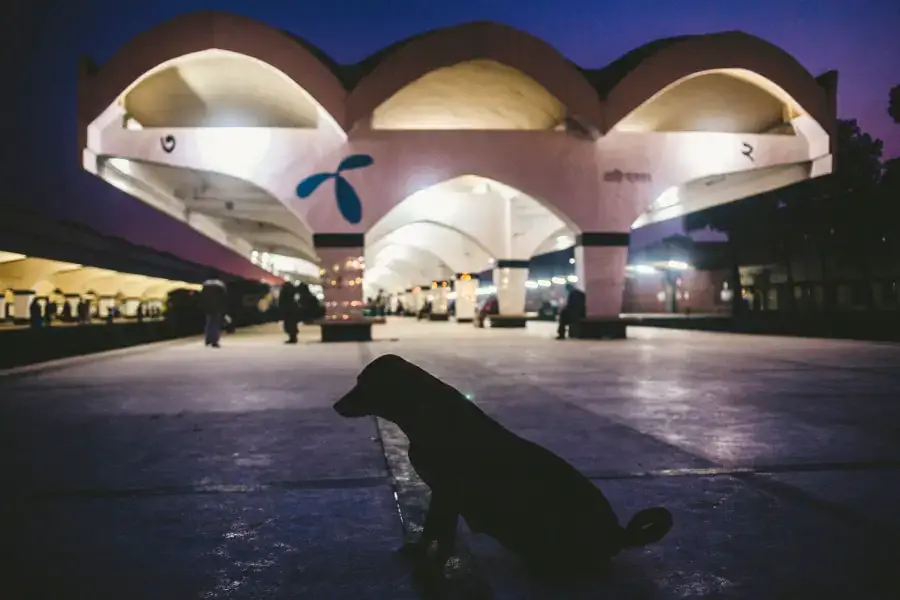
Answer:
604, 31, 836, 135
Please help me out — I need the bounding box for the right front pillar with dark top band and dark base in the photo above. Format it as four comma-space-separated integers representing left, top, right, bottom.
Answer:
572, 232, 630, 339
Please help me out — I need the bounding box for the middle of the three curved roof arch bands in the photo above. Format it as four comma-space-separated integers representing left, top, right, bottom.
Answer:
347, 21, 602, 128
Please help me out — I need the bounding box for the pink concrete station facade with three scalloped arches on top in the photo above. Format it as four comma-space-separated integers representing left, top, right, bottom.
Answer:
78, 12, 835, 324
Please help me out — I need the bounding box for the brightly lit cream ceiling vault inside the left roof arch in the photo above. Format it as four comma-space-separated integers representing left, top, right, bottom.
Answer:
122, 50, 319, 127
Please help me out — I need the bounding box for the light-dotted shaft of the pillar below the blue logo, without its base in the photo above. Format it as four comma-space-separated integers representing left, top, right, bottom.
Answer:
313, 233, 365, 322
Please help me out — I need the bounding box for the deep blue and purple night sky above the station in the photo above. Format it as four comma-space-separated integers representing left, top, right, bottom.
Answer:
0, 0, 900, 274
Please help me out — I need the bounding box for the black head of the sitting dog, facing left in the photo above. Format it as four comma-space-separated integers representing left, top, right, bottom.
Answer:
334, 354, 437, 420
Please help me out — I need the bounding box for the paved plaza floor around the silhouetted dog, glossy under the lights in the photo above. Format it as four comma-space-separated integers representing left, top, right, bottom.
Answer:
0, 320, 900, 600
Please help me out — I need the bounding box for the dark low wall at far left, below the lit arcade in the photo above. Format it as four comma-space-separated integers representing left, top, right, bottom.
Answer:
0, 321, 203, 369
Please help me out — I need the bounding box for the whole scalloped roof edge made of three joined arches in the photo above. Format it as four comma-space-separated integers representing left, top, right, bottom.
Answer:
81, 11, 834, 136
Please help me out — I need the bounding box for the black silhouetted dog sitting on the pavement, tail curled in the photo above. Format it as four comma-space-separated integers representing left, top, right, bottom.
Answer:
334, 354, 672, 573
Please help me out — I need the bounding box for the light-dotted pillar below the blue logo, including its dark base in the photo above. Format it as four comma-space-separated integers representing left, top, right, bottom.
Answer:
313, 233, 372, 342
